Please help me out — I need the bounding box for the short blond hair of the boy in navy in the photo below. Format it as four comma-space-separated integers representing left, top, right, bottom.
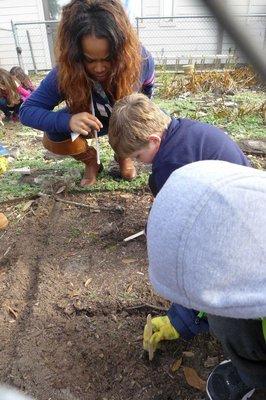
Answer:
108, 93, 171, 157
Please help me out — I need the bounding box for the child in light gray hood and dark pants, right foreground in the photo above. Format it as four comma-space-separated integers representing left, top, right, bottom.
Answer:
147, 161, 266, 400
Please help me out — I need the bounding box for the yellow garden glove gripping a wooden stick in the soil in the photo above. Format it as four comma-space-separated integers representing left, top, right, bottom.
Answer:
143, 315, 180, 351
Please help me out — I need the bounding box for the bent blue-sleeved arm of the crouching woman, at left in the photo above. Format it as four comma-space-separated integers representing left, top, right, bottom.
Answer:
20, 68, 71, 133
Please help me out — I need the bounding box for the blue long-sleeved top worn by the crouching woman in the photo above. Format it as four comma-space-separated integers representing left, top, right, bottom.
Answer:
20, 47, 154, 142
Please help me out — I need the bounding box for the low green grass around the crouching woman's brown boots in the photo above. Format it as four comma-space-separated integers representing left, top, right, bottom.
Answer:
0, 138, 148, 202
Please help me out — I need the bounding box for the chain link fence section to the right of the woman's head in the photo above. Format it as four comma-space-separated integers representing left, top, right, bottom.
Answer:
136, 14, 266, 69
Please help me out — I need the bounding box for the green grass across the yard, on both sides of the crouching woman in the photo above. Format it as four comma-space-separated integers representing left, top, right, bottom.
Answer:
0, 91, 266, 201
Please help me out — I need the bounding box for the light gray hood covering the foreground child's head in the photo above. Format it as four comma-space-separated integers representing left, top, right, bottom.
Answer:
147, 160, 266, 318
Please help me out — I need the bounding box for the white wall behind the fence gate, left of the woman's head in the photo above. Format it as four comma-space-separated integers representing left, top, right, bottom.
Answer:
0, 0, 51, 70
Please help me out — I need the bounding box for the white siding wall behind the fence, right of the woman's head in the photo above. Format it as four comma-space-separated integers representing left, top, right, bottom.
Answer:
136, 0, 266, 63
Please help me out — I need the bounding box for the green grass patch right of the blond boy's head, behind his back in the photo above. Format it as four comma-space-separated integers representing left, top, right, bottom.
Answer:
155, 91, 266, 140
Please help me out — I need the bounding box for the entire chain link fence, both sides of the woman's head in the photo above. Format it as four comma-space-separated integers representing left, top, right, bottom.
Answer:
6, 14, 266, 72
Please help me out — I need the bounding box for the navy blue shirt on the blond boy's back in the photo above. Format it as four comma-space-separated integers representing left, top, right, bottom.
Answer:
149, 118, 249, 196
